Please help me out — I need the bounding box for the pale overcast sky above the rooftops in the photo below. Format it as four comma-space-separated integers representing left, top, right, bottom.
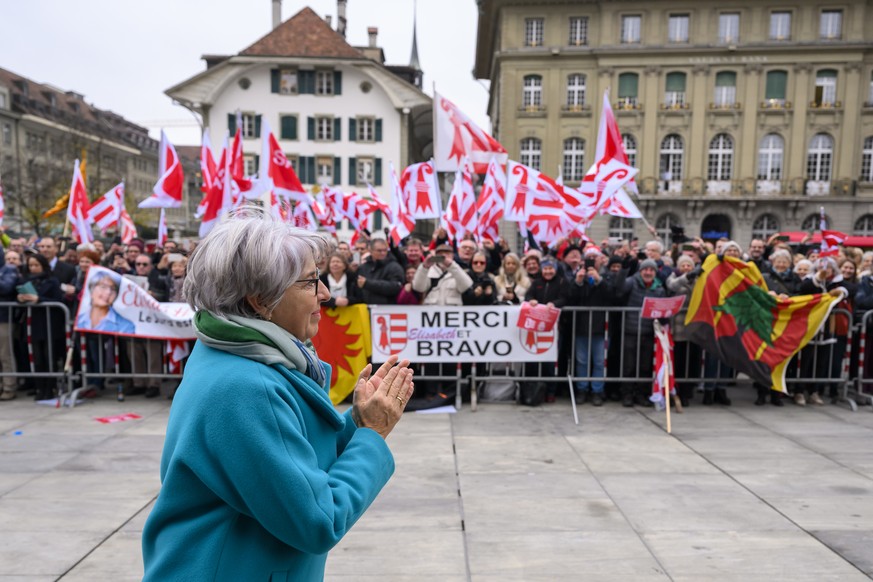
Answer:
0, 0, 490, 145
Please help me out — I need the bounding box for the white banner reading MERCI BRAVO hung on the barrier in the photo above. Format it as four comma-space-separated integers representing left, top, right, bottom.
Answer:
370, 305, 558, 363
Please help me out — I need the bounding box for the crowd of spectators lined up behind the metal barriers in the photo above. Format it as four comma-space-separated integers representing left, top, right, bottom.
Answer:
0, 230, 873, 408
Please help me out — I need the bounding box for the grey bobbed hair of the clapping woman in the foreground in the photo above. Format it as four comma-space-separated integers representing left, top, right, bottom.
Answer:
182, 206, 331, 317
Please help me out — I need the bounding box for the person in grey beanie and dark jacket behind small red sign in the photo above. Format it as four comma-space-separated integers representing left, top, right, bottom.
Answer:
614, 259, 666, 406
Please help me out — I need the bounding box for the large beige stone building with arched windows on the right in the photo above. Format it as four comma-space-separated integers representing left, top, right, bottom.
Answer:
474, 0, 873, 245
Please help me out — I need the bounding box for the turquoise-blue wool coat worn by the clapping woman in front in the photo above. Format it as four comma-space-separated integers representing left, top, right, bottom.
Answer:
142, 342, 394, 582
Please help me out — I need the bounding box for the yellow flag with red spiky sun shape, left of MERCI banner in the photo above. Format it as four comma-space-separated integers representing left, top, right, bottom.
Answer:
312, 304, 373, 404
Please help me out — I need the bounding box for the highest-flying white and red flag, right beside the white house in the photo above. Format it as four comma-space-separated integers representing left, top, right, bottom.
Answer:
432, 92, 508, 175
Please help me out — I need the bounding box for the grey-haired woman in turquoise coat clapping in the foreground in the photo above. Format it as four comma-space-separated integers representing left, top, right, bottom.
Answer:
142, 208, 413, 581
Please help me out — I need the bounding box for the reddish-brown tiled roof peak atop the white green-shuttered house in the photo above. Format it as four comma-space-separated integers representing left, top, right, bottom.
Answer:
240, 7, 365, 59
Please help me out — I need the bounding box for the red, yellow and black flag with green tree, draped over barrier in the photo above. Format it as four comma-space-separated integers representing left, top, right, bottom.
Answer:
685, 255, 841, 392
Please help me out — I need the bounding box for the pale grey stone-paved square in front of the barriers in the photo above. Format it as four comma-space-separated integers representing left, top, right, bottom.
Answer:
0, 388, 873, 582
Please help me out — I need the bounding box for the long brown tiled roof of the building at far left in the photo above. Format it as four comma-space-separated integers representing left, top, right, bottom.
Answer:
0, 68, 158, 150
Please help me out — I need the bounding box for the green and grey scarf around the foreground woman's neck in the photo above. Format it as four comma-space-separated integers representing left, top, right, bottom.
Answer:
194, 311, 327, 388
